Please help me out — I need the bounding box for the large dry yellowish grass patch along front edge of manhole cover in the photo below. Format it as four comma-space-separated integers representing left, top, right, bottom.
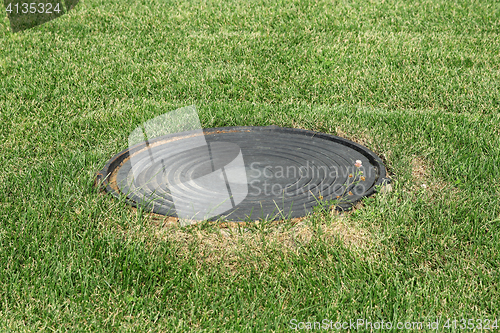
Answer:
112, 212, 374, 272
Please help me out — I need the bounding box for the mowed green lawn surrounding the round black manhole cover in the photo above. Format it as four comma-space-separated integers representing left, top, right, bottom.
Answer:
0, 0, 500, 332
